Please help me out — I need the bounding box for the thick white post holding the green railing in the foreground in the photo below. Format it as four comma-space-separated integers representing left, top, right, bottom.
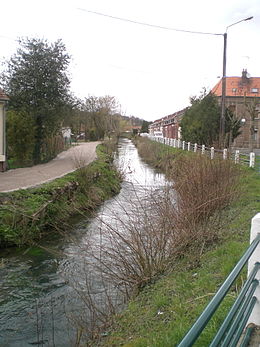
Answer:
247, 213, 260, 325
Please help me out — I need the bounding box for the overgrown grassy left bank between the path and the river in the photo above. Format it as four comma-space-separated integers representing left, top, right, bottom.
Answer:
0, 140, 120, 248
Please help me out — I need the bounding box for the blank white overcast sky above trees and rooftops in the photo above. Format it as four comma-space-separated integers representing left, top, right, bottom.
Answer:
0, 0, 260, 121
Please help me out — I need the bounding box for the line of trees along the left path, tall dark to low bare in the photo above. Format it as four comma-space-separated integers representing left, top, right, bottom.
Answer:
0, 38, 144, 169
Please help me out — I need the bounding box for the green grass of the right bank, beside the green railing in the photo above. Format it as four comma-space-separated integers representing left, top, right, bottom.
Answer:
99, 142, 260, 347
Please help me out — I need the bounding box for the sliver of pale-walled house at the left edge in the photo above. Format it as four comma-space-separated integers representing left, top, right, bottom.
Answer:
0, 89, 8, 171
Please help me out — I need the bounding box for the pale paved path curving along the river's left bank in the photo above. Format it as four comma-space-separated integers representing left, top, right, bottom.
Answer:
0, 142, 100, 192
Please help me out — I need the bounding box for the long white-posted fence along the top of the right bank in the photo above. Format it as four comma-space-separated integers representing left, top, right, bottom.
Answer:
149, 136, 255, 167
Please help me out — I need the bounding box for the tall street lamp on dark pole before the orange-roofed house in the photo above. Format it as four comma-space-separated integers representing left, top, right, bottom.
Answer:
219, 16, 253, 145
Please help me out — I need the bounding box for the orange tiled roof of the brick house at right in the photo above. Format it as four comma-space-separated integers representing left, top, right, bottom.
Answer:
211, 77, 260, 97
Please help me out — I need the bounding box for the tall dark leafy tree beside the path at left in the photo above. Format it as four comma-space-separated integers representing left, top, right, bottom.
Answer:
1, 38, 70, 164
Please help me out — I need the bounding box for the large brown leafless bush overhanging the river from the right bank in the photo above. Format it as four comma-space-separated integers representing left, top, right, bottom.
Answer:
66, 157, 242, 344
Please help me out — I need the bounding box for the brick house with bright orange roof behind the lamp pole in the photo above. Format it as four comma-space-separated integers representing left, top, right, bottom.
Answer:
211, 69, 260, 150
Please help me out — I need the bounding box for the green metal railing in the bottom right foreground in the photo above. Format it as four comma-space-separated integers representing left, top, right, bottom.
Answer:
178, 234, 260, 347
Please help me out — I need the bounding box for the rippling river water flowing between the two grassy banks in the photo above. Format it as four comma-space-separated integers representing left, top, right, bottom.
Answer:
0, 138, 167, 347
